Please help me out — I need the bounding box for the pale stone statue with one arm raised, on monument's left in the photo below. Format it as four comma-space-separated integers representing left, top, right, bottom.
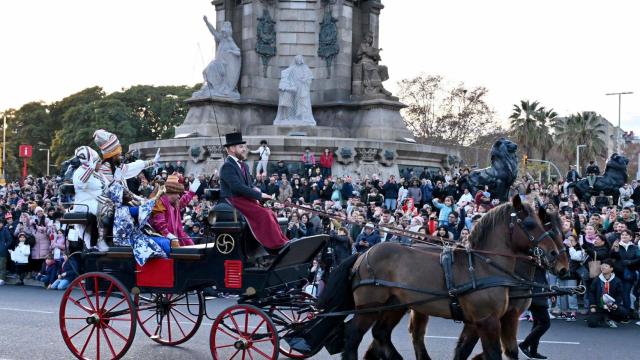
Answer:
193, 16, 241, 99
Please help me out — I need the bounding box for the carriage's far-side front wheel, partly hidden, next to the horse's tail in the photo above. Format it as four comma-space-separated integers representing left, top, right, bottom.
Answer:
269, 292, 317, 359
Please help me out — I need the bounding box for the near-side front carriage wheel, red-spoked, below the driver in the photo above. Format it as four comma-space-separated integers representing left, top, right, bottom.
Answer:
210, 304, 279, 360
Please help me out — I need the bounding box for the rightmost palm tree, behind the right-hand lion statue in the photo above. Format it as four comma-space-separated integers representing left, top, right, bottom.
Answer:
554, 111, 607, 171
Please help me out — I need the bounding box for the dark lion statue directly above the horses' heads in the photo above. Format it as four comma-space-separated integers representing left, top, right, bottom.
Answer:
469, 138, 518, 202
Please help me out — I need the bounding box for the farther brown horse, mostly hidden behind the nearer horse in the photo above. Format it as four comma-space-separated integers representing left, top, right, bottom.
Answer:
409, 205, 569, 360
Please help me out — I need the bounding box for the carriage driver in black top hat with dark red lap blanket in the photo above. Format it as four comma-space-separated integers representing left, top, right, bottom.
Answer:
220, 132, 288, 252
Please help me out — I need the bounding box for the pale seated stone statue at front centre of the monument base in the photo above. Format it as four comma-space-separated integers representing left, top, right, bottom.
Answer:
273, 55, 316, 126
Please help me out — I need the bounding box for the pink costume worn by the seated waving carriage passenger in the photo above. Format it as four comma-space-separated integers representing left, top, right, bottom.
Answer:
149, 191, 195, 246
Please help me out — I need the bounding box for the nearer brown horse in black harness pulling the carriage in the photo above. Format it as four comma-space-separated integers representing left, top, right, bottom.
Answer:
342, 196, 564, 360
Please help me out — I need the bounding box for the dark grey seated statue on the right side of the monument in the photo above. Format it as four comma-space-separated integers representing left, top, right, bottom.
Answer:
353, 32, 391, 96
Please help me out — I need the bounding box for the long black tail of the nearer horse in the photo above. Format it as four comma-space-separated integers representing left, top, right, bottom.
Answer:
318, 253, 360, 311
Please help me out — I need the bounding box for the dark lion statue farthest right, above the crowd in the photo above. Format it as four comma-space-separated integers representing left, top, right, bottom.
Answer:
569, 153, 629, 203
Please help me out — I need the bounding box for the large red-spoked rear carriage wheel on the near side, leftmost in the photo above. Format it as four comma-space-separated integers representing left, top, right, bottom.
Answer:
59, 272, 136, 359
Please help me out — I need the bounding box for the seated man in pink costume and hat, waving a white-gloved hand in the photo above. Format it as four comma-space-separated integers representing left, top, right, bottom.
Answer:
149, 175, 200, 248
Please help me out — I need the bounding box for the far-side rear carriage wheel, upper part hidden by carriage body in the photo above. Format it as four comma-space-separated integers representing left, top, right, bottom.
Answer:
134, 292, 204, 346
